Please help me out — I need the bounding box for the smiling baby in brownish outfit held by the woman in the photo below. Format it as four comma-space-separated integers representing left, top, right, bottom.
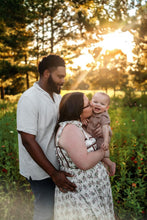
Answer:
84, 92, 116, 176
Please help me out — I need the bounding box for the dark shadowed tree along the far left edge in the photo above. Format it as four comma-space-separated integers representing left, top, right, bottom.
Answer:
0, 0, 32, 98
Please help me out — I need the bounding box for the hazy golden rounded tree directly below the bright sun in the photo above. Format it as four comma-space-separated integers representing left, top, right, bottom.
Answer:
86, 49, 128, 96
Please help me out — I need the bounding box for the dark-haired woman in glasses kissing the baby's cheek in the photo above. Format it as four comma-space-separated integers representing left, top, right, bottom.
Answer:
54, 92, 114, 220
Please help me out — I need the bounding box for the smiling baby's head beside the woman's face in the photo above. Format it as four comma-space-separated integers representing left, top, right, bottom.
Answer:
91, 92, 110, 113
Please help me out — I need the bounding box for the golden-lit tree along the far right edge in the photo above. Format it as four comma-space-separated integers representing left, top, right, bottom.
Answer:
123, 0, 147, 92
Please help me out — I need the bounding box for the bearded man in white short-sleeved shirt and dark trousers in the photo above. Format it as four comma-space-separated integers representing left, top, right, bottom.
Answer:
17, 55, 76, 220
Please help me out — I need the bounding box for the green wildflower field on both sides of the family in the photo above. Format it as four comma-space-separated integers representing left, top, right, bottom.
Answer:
0, 91, 147, 220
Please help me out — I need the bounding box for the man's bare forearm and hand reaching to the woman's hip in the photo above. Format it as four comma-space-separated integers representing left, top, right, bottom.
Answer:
18, 131, 76, 191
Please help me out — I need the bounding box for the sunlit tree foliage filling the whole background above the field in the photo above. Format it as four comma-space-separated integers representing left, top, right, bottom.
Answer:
0, 0, 147, 97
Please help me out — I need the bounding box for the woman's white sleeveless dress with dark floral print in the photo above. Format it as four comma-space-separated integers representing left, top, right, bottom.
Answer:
54, 121, 115, 220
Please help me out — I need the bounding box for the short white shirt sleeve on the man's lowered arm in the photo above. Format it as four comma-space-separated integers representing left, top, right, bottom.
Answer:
17, 96, 38, 135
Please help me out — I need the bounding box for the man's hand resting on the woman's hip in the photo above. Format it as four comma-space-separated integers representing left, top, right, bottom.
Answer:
51, 170, 76, 192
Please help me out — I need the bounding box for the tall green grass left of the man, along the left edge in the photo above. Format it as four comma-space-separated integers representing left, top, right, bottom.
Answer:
0, 101, 33, 220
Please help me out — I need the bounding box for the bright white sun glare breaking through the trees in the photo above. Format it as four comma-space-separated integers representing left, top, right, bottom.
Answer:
72, 30, 135, 71
